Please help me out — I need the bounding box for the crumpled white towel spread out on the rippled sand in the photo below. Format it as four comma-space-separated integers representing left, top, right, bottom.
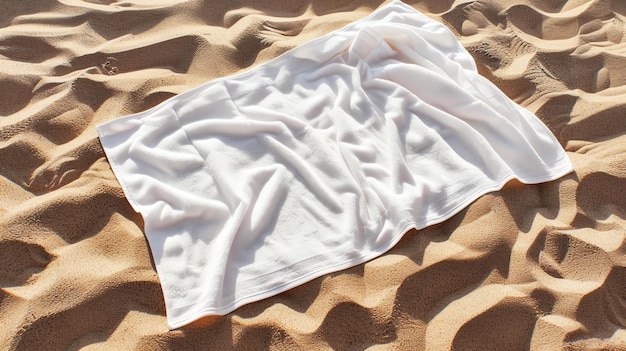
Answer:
98, 2, 572, 328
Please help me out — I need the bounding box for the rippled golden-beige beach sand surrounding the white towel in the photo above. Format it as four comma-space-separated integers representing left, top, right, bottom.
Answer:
0, 0, 626, 351
